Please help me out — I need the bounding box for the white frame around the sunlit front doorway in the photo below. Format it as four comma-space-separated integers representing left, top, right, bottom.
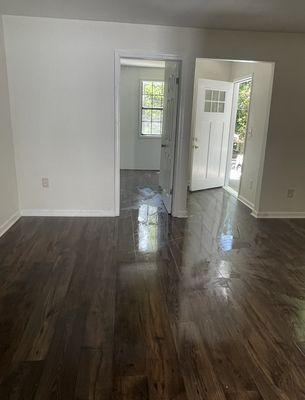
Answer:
224, 74, 254, 198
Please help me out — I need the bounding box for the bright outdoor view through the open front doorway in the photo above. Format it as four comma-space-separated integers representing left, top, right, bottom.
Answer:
228, 78, 252, 194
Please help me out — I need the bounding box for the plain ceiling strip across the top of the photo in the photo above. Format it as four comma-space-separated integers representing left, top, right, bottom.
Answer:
0, 0, 305, 32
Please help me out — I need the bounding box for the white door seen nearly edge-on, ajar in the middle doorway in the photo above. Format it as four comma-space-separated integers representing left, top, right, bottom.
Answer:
159, 61, 180, 214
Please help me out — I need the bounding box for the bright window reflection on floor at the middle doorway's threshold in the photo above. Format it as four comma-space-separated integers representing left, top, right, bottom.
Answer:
138, 204, 158, 252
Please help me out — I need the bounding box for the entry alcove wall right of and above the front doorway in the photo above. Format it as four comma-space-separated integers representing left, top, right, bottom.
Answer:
231, 63, 273, 209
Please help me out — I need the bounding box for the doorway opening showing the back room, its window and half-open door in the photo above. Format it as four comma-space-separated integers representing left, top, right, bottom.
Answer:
116, 54, 181, 220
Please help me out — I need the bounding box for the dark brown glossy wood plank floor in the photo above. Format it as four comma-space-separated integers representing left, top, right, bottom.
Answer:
0, 171, 305, 400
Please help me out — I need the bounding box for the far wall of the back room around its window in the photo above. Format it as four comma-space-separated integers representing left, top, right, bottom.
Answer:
120, 66, 164, 170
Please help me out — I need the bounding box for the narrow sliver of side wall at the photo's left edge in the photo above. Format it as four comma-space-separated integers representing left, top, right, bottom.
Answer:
0, 18, 19, 236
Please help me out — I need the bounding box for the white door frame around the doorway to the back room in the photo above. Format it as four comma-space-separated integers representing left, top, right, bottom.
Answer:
114, 50, 182, 217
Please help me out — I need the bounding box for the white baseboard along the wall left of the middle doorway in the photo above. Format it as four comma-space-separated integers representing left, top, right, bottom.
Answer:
21, 209, 115, 217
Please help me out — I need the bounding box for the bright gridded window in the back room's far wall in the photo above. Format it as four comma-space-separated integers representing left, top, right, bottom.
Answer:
141, 80, 164, 137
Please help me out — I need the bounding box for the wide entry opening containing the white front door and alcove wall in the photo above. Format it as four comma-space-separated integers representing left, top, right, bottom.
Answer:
189, 59, 274, 209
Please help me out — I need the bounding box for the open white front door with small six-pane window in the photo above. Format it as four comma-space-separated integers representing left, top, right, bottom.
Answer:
190, 79, 233, 191
